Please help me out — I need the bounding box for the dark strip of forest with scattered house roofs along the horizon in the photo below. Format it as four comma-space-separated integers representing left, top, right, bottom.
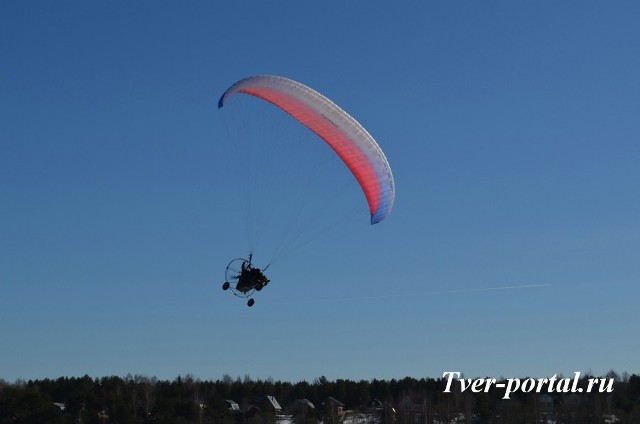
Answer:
0, 371, 640, 424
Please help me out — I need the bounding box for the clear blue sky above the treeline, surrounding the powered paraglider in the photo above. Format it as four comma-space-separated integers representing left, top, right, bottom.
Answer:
0, 1, 640, 381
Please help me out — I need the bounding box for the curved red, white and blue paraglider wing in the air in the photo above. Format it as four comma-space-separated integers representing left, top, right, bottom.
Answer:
218, 75, 395, 224
